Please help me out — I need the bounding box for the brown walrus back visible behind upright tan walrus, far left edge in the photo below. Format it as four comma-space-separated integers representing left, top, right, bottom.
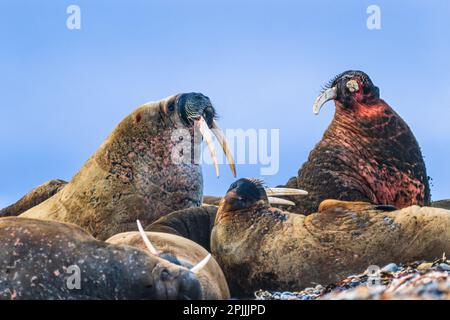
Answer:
0, 180, 67, 217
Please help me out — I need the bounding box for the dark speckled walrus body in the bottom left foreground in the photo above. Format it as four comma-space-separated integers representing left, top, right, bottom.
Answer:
0, 217, 202, 300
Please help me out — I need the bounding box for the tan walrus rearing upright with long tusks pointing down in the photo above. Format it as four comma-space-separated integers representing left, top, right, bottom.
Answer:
17, 93, 236, 240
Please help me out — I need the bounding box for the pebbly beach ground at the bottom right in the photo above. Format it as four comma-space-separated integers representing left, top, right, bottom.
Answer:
255, 255, 450, 300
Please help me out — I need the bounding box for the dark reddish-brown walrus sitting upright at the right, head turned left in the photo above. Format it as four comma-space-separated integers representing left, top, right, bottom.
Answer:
286, 70, 430, 214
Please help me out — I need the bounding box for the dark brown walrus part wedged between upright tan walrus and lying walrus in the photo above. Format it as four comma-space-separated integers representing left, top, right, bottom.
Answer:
146, 205, 217, 251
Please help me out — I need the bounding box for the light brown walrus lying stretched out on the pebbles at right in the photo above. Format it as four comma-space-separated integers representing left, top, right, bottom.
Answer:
211, 179, 450, 297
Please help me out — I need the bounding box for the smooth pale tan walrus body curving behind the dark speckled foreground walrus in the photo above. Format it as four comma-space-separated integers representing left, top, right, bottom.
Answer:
106, 232, 230, 300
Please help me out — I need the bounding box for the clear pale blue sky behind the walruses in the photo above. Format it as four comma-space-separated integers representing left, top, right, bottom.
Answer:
0, 0, 450, 207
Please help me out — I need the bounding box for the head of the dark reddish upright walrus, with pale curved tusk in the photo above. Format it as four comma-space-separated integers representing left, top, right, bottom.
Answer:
313, 70, 380, 114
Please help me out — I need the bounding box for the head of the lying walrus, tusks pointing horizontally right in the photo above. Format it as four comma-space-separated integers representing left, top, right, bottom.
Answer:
215, 178, 308, 224
